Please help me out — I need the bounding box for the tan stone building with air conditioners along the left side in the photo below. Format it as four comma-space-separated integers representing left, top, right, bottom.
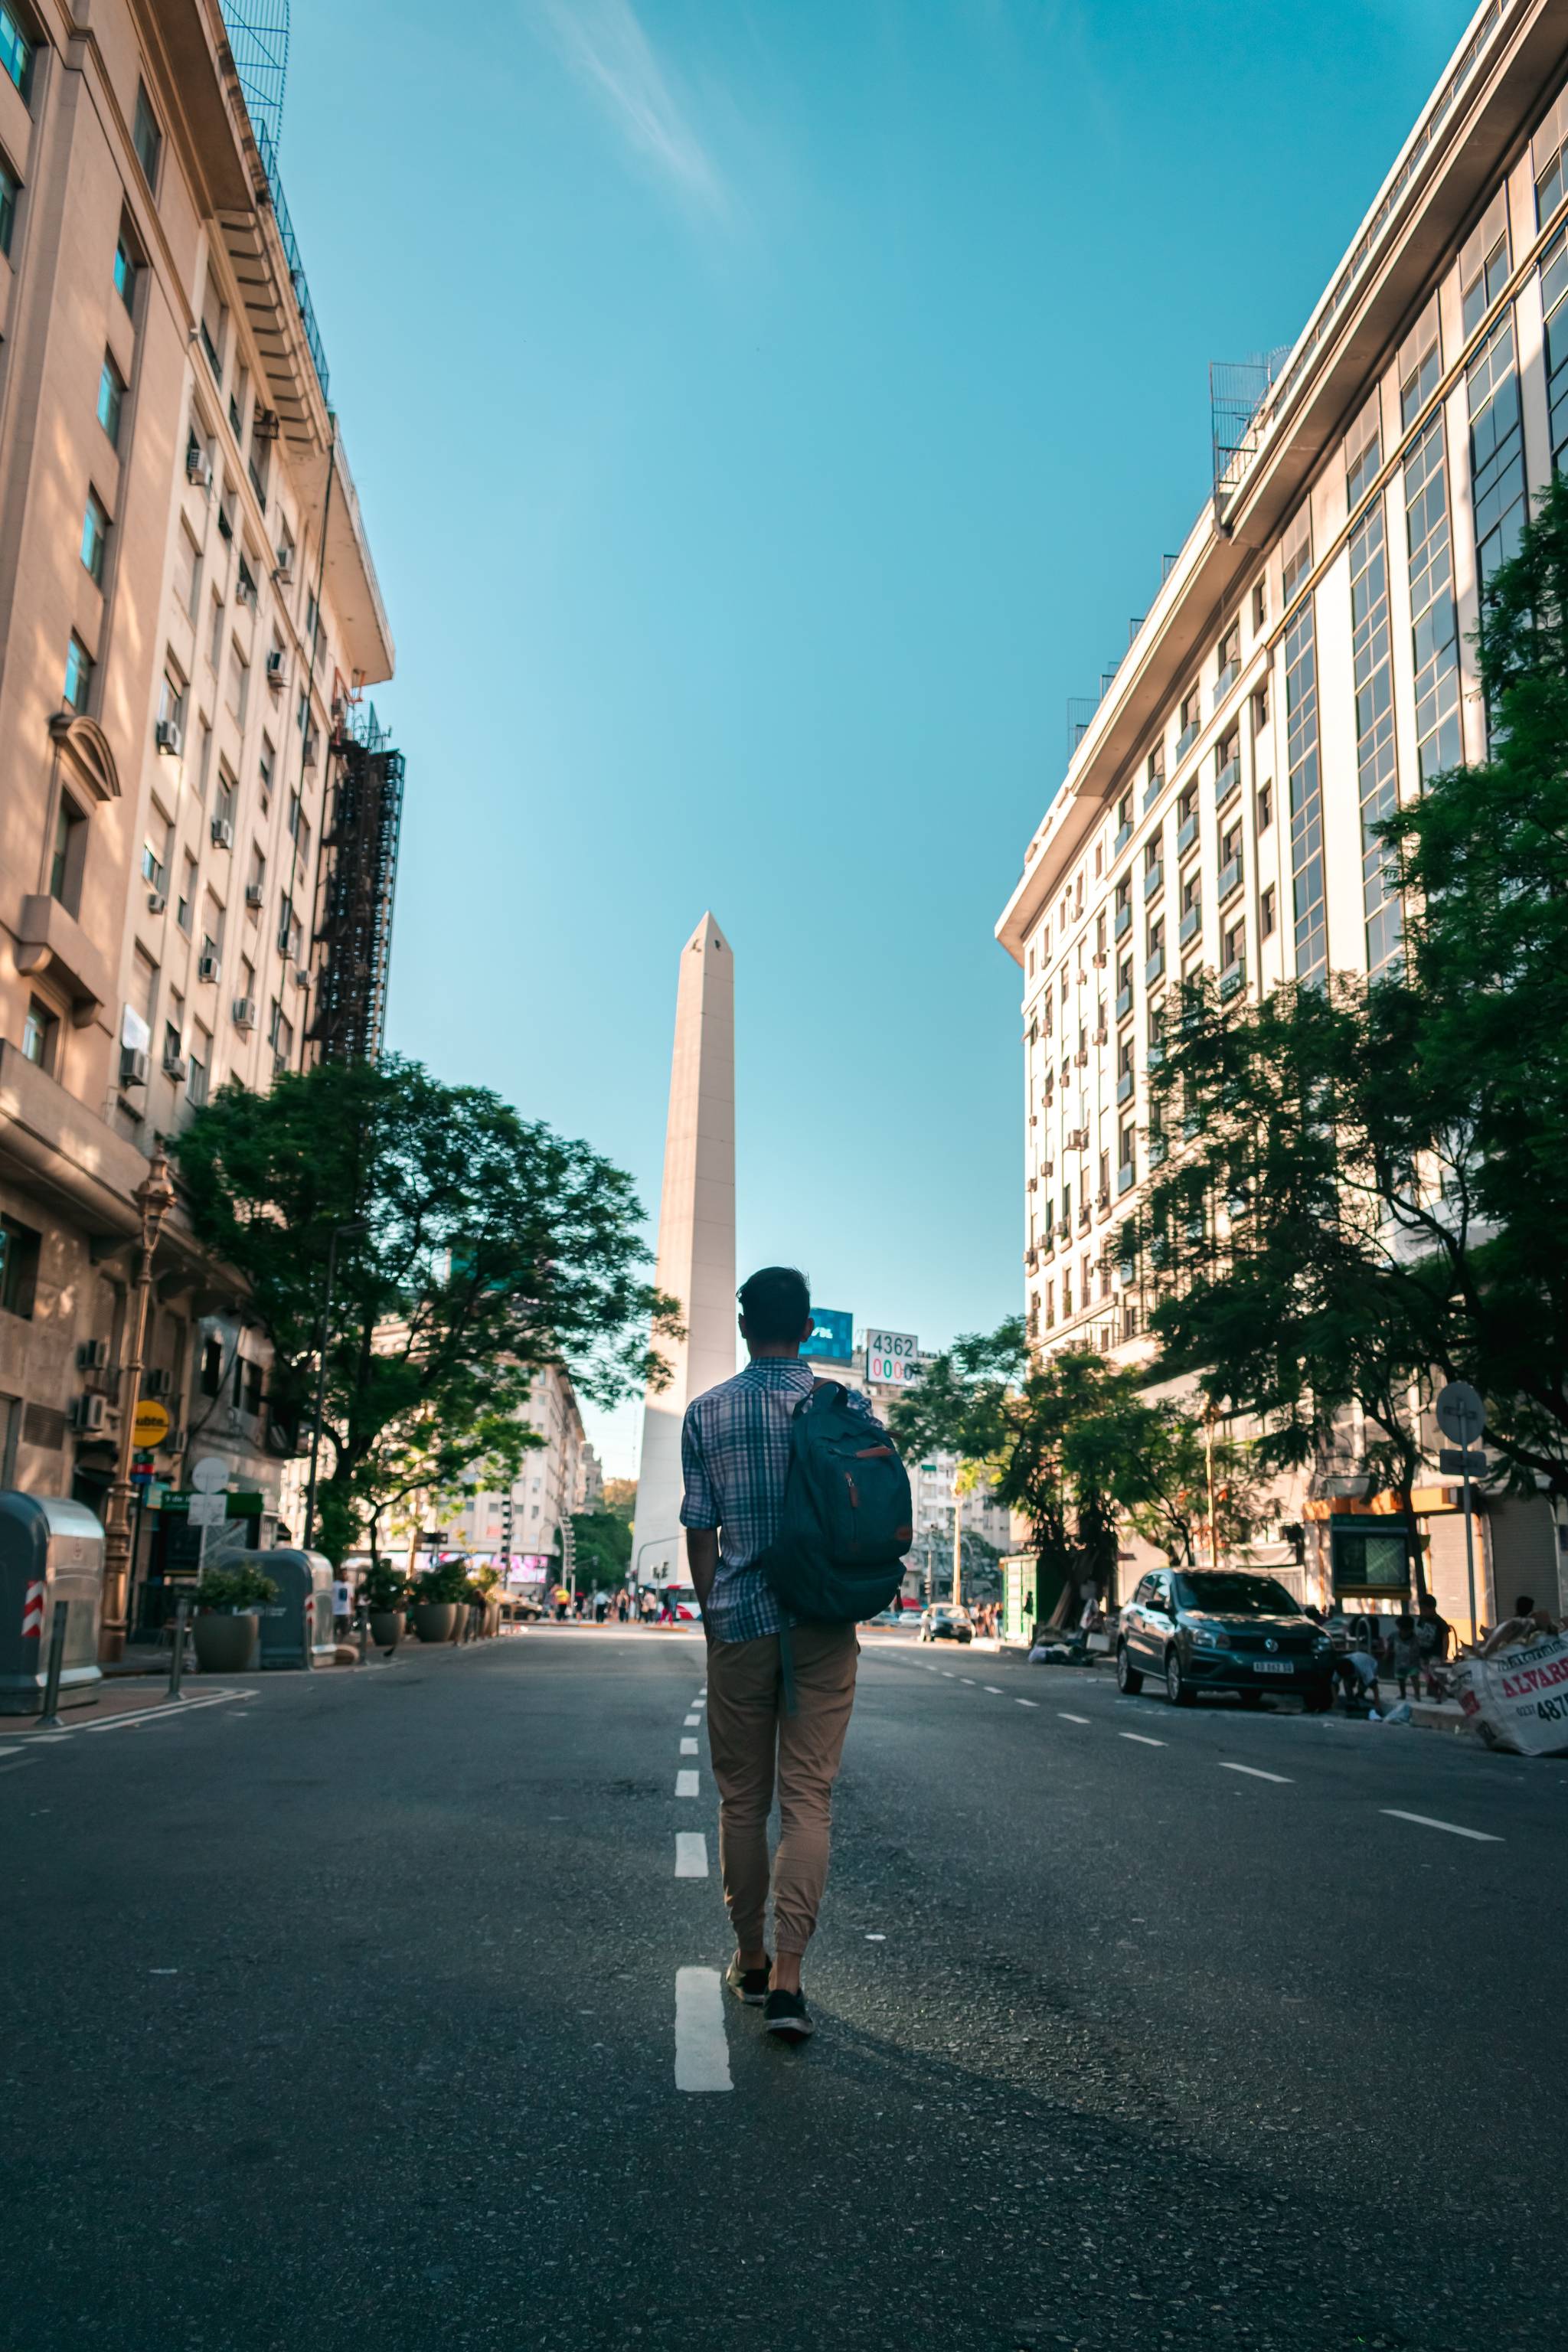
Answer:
0, 0, 393, 1618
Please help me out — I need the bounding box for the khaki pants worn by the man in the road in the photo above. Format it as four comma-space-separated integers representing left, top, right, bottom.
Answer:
707, 1625, 861, 1952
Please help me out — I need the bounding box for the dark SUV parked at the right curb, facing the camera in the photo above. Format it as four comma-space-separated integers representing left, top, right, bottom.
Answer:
1116, 1569, 1333, 1714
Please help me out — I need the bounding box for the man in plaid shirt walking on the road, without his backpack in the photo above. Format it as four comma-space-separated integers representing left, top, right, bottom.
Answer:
681, 1266, 863, 2041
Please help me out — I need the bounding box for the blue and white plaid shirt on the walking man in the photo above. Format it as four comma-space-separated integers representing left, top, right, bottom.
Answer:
681, 1354, 870, 1642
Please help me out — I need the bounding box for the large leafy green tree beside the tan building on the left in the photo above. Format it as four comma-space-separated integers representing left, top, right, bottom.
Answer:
174, 1056, 677, 1560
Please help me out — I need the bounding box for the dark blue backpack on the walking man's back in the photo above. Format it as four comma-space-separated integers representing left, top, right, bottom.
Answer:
755, 1380, 914, 1625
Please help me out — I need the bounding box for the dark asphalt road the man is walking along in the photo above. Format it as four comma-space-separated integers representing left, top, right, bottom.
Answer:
0, 1630, 1568, 2352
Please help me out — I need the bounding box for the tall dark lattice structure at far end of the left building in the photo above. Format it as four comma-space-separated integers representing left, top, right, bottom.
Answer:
308, 704, 402, 1060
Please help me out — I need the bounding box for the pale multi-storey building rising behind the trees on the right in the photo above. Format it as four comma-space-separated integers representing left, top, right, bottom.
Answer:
997, 0, 1568, 1615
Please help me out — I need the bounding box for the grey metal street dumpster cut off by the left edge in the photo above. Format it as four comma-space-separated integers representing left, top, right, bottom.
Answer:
0, 1489, 103, 1714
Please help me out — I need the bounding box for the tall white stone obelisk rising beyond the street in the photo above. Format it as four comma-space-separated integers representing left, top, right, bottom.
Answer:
632, 915, 736, 1586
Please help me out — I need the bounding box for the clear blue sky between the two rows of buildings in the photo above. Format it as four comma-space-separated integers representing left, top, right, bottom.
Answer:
282, 0, 1469, 1470
